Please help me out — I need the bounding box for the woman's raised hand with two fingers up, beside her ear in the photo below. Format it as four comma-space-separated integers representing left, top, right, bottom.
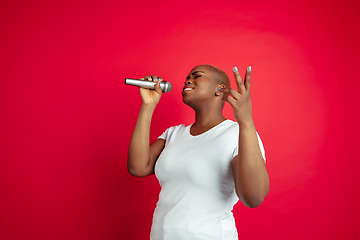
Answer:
222, 67, 254, 125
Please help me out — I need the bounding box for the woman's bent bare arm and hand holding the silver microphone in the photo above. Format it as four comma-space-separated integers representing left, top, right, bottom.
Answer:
127, 76, 165, 177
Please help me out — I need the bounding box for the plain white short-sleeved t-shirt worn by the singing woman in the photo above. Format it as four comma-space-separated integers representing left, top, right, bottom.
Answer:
150, 120, 265, 240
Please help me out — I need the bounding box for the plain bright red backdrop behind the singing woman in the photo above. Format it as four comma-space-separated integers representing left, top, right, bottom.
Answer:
0, 0, 360, 240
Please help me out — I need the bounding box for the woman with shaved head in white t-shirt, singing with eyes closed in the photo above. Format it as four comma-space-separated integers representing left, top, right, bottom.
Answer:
128, 65, 269, 240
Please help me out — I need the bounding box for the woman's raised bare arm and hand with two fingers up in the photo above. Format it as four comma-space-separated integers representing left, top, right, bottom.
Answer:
222, 67, 269, 207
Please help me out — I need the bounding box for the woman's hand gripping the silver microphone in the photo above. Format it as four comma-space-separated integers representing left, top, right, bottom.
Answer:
139, 75, 162, 107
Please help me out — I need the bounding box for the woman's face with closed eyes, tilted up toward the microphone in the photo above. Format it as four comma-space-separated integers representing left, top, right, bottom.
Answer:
182, 65, 219, 107
